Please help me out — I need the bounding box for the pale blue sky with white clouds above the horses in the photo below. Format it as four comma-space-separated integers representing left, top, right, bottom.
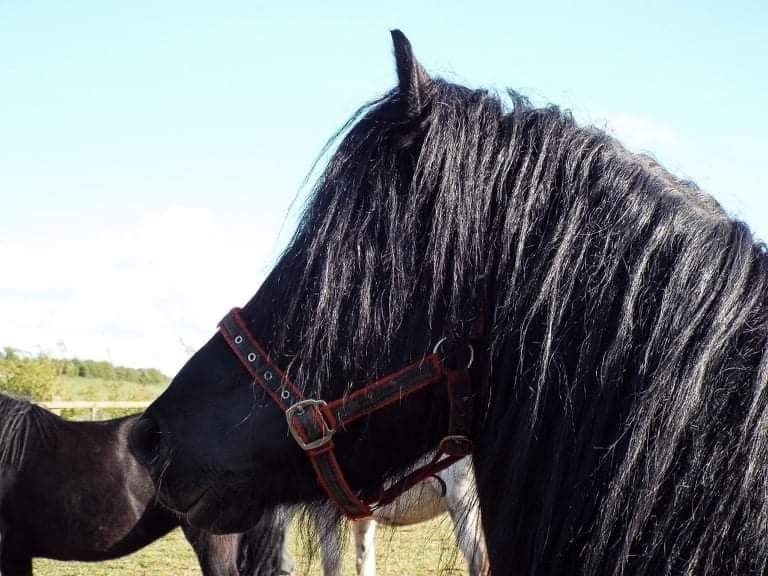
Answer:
0, 0, 768, 373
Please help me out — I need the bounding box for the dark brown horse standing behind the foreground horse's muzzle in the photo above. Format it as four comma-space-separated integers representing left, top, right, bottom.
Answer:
0, 394, 292, 576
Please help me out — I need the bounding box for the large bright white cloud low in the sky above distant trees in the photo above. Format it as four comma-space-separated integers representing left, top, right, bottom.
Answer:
0, 206, 286, 375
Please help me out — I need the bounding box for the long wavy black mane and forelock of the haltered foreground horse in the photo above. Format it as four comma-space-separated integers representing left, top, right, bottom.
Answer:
266, 72, 768, 575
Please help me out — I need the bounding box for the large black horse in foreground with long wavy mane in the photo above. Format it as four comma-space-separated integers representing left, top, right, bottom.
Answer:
133, 32, 768, 576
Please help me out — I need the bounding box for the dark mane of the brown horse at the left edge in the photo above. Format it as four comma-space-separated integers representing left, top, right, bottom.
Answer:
0, 393, 55, 470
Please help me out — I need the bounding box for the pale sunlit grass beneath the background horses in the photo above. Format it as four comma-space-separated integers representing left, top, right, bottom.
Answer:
34, 516, 467, 576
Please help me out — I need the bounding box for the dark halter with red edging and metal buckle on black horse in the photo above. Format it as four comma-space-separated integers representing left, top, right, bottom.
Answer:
219, 308, 474, 519
